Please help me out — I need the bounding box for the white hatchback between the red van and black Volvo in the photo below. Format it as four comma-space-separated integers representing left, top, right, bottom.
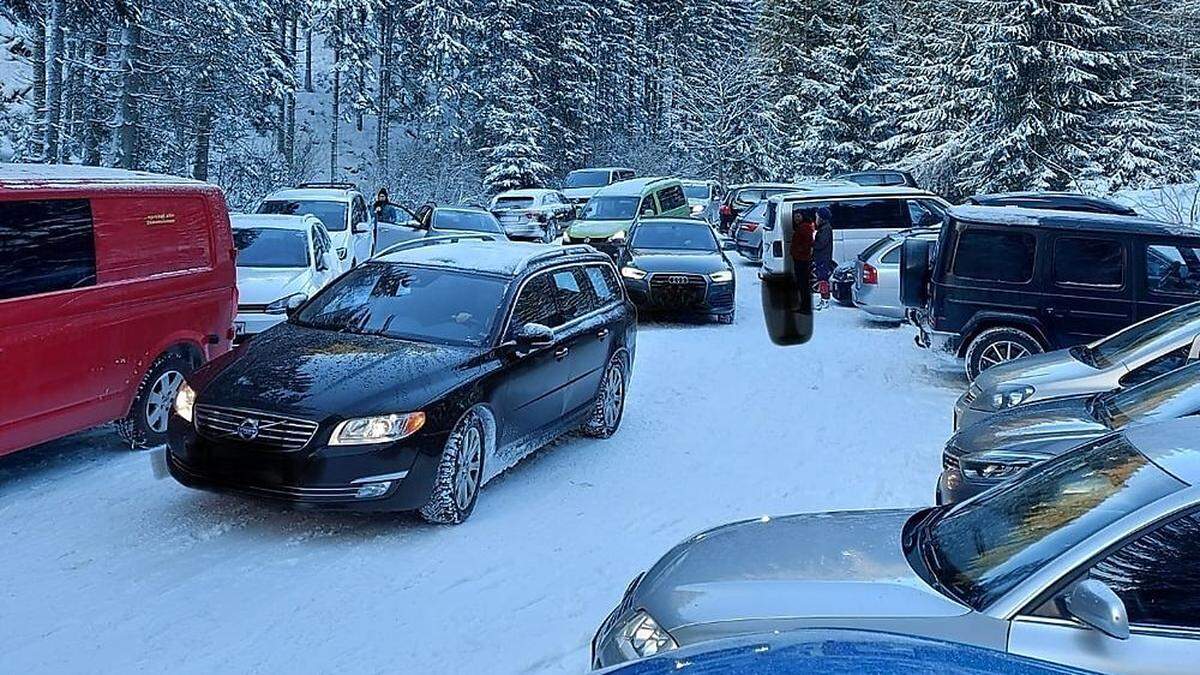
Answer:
229, 215, 348, 340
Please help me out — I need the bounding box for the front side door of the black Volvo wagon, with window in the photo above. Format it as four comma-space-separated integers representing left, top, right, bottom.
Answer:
497, 267, 571, 451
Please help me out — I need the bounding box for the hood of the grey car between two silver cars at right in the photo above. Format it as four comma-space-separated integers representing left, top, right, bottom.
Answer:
947, 396, 1110, 454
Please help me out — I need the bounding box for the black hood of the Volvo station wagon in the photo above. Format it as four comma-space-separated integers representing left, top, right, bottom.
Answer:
188, 323, 486, 420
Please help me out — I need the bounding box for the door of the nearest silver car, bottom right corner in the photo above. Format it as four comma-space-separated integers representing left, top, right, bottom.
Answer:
1008, 513, 1200, 675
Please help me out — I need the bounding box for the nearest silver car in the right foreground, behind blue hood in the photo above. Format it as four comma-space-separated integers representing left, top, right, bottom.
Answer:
592, 420, 1200, 674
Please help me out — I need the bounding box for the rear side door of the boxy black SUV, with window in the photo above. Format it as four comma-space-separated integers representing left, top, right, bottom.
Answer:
1042, 234, 1134, 347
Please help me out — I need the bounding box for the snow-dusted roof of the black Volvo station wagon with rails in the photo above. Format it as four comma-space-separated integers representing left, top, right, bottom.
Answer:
373, 235, 611, 277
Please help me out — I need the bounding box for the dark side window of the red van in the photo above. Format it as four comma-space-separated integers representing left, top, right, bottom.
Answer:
0, 199, 96, 300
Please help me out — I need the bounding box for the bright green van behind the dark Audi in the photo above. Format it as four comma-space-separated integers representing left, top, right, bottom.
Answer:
563, 178, 691, 257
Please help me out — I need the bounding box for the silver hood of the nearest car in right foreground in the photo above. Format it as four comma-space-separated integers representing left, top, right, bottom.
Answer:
635, 509, 970, 632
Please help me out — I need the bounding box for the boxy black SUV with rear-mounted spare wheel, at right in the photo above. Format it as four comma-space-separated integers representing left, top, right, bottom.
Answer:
900, 205, 1200, 380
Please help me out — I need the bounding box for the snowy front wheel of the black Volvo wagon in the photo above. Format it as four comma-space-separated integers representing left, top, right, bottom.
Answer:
420, 410, 487, 525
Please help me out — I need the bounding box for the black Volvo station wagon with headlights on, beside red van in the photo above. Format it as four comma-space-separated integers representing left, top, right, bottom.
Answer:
166, 235, 636, 522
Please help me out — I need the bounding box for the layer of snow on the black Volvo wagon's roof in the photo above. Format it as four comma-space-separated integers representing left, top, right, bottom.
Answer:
376, 239, 607, 276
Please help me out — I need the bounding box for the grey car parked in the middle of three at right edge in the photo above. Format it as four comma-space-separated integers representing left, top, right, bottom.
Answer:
937, 362, 1200, 503
